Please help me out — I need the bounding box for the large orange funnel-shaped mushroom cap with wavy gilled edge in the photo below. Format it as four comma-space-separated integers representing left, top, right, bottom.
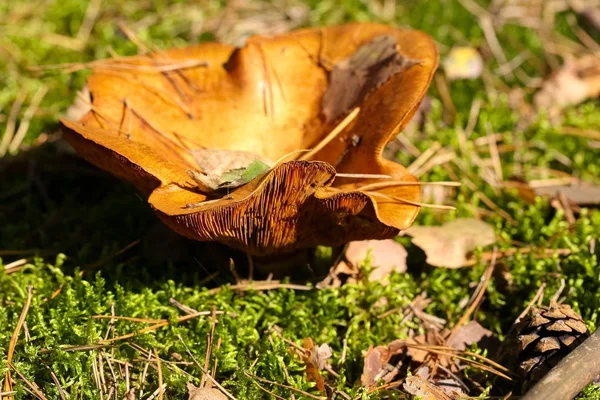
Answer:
62, 24, 438, 256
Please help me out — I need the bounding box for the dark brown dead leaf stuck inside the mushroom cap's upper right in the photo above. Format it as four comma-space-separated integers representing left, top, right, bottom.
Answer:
322, 35, 419, 122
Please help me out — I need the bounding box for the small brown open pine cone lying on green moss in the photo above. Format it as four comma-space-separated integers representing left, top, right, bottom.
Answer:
517, 303, 589, 385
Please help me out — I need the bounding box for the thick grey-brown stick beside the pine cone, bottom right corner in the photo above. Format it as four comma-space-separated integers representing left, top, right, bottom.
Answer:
522, 329, 600, 400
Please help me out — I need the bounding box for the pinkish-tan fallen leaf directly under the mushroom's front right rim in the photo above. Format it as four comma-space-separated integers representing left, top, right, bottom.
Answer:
346, 239, 408, 282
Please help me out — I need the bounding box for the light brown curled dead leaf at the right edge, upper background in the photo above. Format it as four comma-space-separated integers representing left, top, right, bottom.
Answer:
533, 55, 600, 115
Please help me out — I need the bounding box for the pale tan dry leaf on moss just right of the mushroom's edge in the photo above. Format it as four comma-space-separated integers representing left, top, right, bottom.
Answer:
406, 218, 496, 268
